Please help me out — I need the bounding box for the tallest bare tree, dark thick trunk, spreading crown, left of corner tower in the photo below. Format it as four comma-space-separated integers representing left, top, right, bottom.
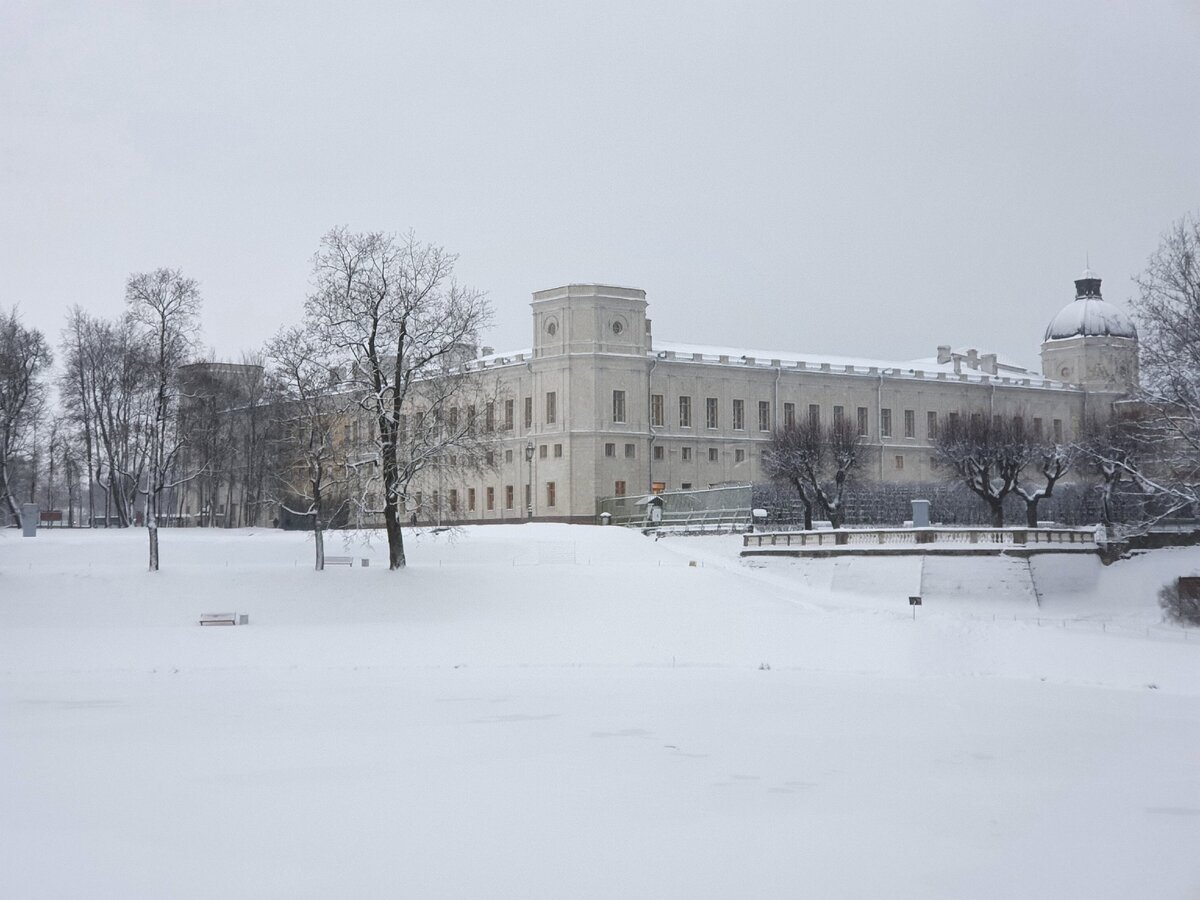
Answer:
306, 228, 491, 569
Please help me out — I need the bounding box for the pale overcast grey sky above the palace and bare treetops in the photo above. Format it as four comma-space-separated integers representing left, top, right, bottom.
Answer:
7, 0, 1200, 365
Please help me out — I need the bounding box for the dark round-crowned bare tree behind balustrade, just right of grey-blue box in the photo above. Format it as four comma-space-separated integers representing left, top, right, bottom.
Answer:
934, 413, 1037, 528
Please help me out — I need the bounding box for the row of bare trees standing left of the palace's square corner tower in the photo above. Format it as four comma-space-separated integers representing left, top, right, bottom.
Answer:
0, 228, 496, 570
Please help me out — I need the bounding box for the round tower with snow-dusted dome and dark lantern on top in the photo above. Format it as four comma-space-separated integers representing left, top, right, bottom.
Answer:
1042, 269, 1138, 391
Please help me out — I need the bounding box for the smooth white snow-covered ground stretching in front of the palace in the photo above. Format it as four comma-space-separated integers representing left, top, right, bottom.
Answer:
0, 524, 1200, 900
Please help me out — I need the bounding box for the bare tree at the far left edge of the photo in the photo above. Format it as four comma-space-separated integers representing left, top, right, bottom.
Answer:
0, 308, 50, 521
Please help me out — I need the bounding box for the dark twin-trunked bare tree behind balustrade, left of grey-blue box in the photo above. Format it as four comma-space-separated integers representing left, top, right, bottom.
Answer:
763, 419, 870, 529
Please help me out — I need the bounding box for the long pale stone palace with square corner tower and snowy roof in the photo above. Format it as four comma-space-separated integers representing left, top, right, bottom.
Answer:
409, 271, 1138, 522
